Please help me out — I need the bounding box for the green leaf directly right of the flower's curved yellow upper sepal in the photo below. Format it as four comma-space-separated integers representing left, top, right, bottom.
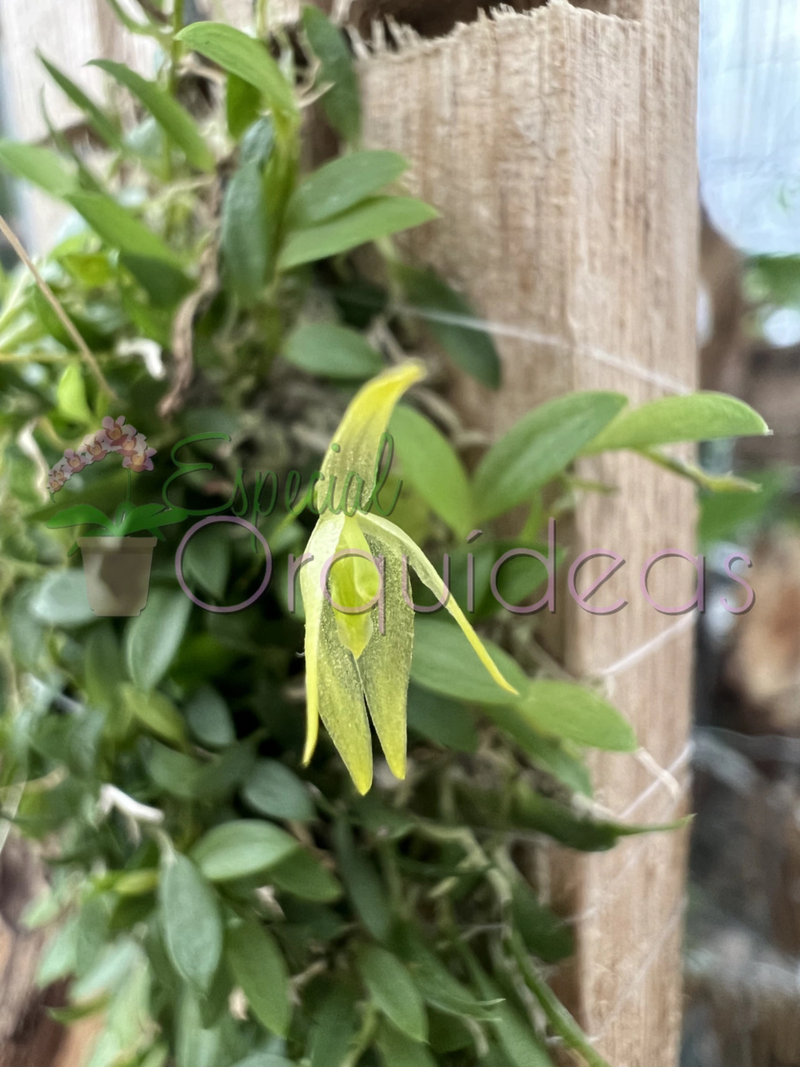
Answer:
389, 404, 474, 538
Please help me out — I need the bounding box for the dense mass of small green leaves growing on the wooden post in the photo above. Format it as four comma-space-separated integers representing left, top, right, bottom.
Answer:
0, 2, 764, 1067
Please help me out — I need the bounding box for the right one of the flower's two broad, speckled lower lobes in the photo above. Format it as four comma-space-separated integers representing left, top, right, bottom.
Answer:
356, 516, 414, 778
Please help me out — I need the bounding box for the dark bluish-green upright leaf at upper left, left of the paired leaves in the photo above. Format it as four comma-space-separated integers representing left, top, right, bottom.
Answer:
222, 160, 270, 307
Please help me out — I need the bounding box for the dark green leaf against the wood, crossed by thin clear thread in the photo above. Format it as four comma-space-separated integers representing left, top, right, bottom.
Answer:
391, 264, 501, 389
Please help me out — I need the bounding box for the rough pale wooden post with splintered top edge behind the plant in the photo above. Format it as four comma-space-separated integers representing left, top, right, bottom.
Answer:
362, 0, 698, 1067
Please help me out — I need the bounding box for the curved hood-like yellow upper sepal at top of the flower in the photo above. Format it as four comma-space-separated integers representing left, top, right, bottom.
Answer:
315, 360, 426, 511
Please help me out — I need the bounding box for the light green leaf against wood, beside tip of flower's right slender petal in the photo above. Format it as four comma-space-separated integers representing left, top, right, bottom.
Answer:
515, 679, 637, 752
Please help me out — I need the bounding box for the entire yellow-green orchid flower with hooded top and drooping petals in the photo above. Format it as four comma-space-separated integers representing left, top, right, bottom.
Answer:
300, 361, 516, 793
